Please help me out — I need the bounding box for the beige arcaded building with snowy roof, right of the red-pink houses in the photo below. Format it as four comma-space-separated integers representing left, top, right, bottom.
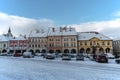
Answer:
28, 31, 47, 53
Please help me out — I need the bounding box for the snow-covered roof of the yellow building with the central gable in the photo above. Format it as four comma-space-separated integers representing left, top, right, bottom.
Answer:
78, 31, 112, 40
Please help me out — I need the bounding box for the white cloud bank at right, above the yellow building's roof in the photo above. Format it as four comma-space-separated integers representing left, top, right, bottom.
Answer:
70, 18, 120, 38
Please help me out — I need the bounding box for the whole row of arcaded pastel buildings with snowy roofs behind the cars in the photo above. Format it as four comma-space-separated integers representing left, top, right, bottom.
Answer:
0, 27, 113, 54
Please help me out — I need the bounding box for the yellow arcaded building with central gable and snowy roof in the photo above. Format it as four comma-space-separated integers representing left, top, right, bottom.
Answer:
78, 32, 113, 54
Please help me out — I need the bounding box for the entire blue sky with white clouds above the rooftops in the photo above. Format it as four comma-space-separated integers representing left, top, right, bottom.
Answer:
0, 0, 120, 38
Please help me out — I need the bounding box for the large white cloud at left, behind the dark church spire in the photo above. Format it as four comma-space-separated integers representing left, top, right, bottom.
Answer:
0, 12, 54, 35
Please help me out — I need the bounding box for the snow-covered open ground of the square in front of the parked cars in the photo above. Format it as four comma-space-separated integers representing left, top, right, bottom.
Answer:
0, 56, 120, 80
